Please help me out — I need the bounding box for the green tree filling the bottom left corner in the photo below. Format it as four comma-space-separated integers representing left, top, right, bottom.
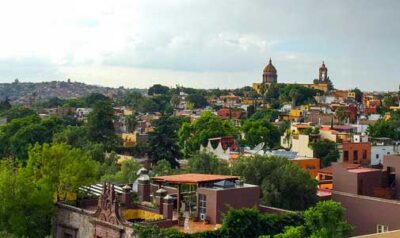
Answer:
0, 160, 55, 237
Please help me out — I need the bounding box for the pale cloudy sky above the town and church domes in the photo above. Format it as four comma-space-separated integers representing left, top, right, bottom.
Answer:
0, 0, 400, 91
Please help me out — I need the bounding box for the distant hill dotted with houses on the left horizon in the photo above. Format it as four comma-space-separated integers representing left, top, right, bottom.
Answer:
0, 81, 142, 105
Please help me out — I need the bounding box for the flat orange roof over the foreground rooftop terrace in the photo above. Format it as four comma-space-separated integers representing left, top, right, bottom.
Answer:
152, 174, 240, 184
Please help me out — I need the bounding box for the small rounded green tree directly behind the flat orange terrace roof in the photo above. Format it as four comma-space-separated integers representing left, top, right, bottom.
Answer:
187, 152, 230, 174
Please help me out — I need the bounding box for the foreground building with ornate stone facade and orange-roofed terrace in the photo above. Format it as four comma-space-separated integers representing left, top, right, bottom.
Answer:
56, 168, 264, 238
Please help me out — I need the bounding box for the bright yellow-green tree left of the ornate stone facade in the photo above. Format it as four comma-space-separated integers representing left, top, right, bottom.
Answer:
27, 144, 98, 201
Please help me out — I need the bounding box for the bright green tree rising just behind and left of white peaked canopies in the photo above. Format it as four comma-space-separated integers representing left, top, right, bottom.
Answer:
178, 111, 239, 155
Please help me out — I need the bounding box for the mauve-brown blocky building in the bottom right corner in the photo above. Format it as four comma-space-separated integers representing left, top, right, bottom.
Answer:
332, 155, 400, 237
